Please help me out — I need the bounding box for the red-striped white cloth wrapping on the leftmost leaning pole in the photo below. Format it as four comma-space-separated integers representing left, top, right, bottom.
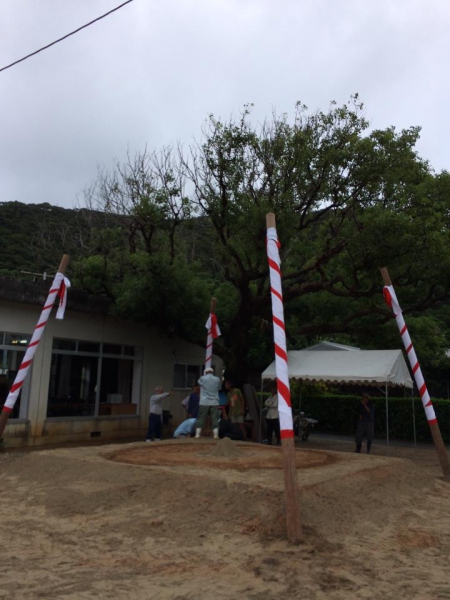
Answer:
3, 272, 70, 413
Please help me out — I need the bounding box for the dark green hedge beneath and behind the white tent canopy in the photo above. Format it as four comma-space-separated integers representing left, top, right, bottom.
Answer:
294, 395, 450, 442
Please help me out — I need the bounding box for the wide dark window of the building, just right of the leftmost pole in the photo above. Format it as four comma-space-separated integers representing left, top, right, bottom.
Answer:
47, 338, 143, 417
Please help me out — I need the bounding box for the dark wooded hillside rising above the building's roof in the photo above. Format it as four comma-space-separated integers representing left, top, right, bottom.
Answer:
0, 202, 214, 278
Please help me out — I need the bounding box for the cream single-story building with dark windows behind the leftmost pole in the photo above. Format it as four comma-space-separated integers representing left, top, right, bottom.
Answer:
0, 278, 222, 447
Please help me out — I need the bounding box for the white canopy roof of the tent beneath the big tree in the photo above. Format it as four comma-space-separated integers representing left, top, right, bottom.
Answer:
262, 350, 413, 388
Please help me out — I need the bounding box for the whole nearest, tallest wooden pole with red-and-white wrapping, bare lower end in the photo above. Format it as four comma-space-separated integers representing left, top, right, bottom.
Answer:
266, 213, 302, 543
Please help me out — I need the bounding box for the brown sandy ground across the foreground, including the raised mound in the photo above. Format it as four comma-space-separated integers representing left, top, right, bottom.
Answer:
0, 439, 450, 600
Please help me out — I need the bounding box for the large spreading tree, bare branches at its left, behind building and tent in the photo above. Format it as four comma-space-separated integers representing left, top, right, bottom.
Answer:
75, 98, 450, 380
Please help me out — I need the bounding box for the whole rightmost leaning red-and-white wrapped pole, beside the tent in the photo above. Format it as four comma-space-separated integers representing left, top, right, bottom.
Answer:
380, 267, 450, 479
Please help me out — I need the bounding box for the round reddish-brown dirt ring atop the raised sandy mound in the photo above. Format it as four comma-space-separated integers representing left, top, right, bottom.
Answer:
105, 438, 338, 470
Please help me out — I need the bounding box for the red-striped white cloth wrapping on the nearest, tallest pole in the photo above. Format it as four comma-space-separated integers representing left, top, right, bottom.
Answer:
267, 227, 294, 439
